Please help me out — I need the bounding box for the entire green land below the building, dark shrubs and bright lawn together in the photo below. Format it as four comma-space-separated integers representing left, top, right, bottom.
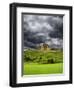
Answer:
23, 50, 63, 75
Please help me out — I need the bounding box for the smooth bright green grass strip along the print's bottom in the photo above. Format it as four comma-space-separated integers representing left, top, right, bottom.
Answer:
23, 63, 63, 75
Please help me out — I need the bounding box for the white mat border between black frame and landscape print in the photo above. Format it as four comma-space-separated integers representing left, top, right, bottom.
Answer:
17, 7, 69, 83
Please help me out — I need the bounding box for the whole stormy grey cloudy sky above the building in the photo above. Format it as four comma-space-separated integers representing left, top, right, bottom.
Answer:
22, 14, 63, 48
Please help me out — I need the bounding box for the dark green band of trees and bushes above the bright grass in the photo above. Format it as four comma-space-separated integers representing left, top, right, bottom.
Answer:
24, 51, 63, 64
